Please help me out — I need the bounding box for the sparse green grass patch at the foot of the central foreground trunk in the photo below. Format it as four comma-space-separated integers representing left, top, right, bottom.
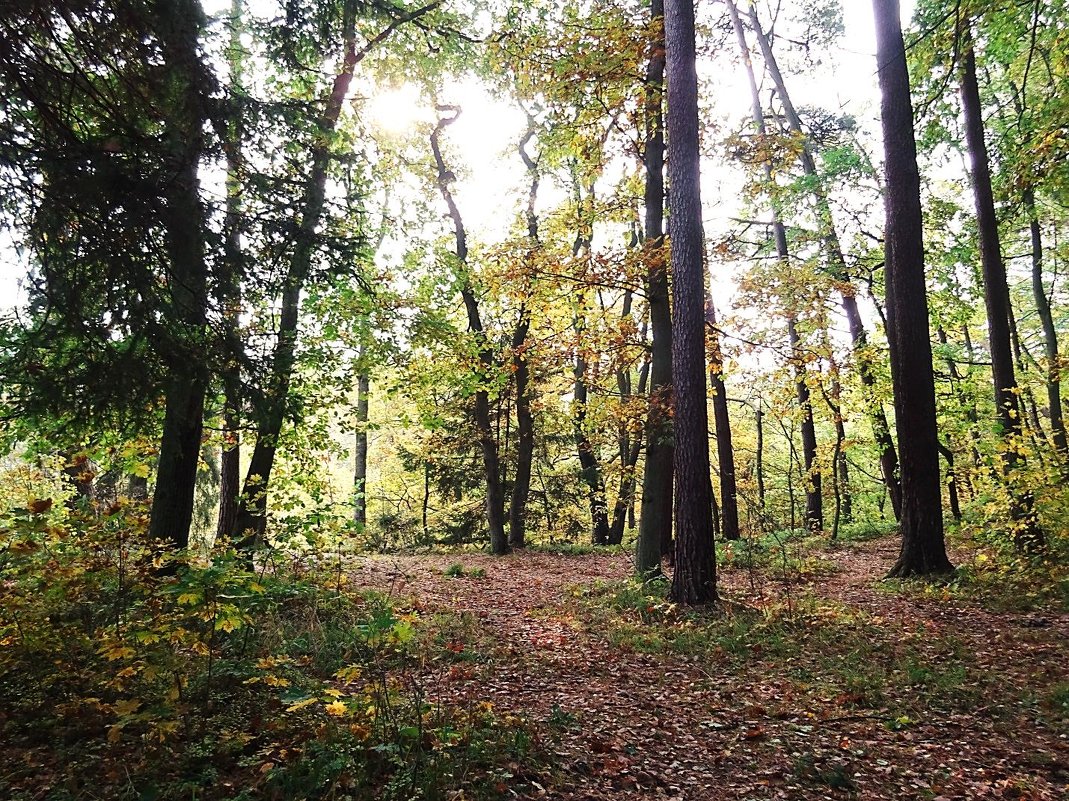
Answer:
576, 582, 993, 720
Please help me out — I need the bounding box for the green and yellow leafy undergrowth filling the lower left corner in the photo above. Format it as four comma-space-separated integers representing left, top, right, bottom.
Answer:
0, 505, 538, 801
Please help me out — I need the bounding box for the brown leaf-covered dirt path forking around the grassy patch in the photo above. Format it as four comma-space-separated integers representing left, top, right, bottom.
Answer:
348, 540, 1069, 801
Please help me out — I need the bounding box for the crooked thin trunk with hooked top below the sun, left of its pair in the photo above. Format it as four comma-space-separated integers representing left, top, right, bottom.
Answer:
431, 106, 510, 556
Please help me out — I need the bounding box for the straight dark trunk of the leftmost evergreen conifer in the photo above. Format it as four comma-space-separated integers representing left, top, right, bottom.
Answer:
149, 0, 211, 549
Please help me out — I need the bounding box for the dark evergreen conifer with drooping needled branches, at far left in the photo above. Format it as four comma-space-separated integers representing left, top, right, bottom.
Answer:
0, 0, 215, 548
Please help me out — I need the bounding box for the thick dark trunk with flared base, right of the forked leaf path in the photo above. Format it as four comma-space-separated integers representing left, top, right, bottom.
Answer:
872, 0, 952, 577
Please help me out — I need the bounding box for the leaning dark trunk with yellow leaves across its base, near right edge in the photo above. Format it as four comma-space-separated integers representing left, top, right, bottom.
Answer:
959, 19, 1043, 550
